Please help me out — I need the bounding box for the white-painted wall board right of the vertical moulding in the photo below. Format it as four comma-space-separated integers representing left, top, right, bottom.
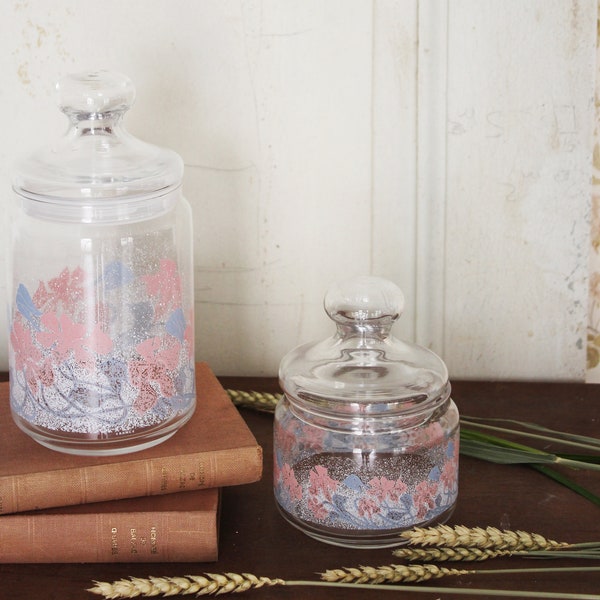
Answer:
443, 0, 596, 380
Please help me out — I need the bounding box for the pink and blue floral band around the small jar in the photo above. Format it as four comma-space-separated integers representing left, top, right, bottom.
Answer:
274, 411, 459, 531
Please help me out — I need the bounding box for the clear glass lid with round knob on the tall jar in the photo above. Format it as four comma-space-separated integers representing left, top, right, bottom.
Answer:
13, 71, 183, 204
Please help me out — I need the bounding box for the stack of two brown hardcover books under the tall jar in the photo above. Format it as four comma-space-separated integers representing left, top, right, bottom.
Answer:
0, 363, 262, 563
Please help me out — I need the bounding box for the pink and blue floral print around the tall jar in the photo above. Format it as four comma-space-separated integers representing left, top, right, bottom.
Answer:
10, 259, 195, 433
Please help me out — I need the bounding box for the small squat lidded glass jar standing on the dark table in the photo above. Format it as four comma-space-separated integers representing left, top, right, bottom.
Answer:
274, 277, 459, 548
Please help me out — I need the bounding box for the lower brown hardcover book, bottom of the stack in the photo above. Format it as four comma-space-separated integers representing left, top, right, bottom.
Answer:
0, 488, 220, 563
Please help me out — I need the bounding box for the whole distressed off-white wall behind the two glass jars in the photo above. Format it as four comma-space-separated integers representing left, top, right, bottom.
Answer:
0, 0, 596, 379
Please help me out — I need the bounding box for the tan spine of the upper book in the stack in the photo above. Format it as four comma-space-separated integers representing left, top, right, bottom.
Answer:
0, 446, 262, 515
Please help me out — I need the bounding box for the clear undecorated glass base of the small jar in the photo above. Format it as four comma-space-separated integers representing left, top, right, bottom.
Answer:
276, 503, 456, 550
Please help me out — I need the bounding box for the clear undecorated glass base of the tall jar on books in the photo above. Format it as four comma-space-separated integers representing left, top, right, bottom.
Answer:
13, 406, 195, 456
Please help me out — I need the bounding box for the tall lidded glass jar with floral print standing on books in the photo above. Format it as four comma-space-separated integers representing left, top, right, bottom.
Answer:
8, 71, 196, 455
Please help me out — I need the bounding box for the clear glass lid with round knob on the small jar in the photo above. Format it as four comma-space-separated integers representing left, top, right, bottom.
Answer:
279, 276, 450, 413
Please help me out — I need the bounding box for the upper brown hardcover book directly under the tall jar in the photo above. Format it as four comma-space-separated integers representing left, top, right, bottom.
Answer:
0, 363, 262, 514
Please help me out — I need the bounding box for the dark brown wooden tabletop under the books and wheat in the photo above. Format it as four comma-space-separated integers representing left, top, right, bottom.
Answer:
0, 378, 600, 600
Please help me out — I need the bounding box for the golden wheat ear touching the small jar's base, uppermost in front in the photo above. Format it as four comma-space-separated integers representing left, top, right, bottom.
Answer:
401, 525, 569, 551
